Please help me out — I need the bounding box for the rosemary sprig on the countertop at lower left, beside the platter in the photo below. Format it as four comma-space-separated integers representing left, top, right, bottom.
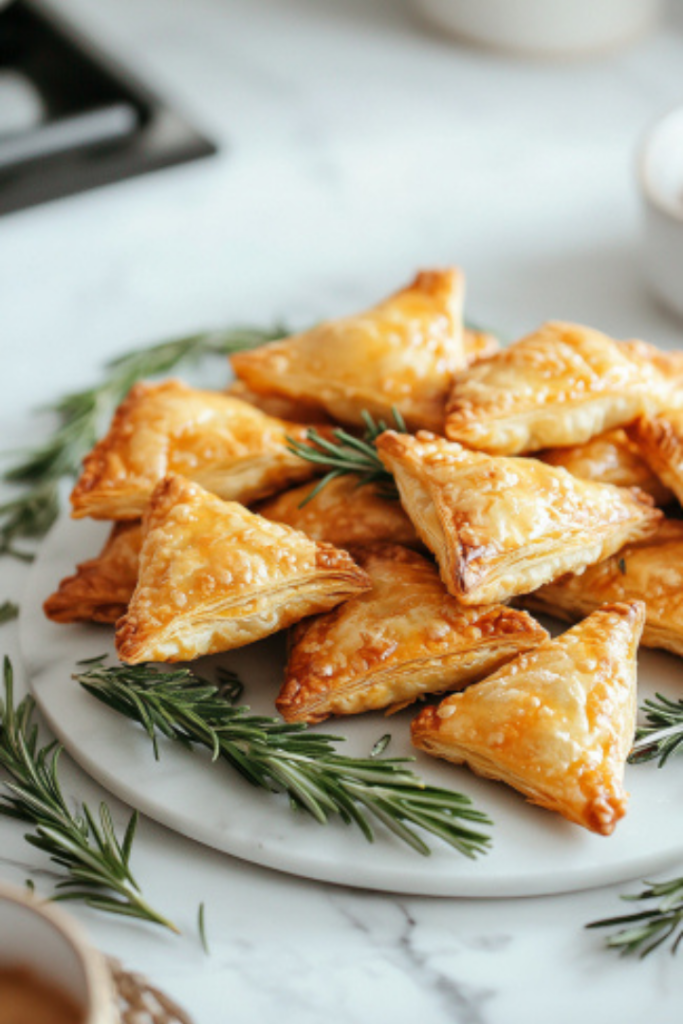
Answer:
0, 657, 177, 932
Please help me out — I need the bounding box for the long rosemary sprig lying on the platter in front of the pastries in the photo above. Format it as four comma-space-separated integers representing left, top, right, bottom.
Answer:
74, 665, 490, 857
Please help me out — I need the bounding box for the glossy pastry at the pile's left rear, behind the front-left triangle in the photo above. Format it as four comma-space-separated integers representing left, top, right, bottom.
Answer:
71, 381, 321, 519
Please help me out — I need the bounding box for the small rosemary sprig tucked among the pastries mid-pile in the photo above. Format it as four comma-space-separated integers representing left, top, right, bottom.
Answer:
287, 407, 408, 508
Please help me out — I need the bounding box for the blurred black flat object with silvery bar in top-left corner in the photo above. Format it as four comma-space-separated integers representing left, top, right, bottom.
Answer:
0, 0, 216, 213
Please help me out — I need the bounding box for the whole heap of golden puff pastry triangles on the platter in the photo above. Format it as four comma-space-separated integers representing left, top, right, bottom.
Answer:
45, 268, 683, 834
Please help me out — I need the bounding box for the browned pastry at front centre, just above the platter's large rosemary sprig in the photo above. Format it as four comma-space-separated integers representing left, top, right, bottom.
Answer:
276, 545, 548, 722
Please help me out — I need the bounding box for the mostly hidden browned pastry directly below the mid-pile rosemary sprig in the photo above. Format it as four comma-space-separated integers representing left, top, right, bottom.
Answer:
255, 473, 422, 548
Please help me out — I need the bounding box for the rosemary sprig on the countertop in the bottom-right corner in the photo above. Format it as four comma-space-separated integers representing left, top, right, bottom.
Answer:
586, 878, 683, 957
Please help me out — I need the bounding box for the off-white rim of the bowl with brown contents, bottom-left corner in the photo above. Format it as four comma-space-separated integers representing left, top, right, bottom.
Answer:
0, 886, 115, 1024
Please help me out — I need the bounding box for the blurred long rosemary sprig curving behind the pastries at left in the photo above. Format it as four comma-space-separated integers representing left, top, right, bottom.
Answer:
0, 327, 284, 560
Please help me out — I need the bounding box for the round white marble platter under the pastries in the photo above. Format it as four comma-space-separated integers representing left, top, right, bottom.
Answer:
22, 517, 683, 897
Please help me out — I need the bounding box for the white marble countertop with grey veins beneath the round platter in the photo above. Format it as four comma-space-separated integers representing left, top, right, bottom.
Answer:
0, 0, 683, 1024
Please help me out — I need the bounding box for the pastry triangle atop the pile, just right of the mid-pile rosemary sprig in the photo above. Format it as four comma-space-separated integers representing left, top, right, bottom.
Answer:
377, 431, 661, 604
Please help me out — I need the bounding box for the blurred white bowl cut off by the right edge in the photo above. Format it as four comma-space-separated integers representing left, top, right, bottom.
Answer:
638, 106, 683, 314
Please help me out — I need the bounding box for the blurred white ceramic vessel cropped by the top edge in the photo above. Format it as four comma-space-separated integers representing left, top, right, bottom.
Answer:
415, 0, 661, 56
